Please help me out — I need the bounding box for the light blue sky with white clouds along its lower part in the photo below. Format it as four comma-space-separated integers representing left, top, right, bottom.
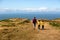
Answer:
0, 0, 60, 11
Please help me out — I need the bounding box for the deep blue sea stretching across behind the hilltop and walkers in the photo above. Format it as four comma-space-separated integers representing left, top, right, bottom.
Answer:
0, 13, 60, 20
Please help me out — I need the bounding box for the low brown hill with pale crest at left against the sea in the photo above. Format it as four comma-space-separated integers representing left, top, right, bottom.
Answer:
0, 18, 30, 27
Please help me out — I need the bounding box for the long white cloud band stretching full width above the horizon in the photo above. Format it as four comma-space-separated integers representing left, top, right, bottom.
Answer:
0, 7, 60, 12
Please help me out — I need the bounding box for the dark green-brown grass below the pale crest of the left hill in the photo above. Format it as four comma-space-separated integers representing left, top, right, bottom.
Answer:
0, 19, 30, 27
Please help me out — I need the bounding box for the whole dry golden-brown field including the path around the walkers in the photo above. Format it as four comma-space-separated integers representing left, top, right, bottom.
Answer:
0, 18, 60, 40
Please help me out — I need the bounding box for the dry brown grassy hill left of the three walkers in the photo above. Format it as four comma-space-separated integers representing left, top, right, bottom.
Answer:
0, 18, 34, 40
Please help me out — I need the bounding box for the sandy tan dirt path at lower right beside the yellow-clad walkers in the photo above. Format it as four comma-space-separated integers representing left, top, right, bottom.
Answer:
36, 23, 60, 40
